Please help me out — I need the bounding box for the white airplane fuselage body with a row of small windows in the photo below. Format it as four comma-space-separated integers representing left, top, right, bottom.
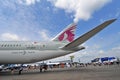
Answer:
0, 41, 74, 64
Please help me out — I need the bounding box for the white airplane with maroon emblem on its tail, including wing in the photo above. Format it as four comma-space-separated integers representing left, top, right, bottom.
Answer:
0, 19, 116, 64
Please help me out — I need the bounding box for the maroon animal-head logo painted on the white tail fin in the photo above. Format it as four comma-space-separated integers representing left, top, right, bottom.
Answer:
58, 25, 76, 42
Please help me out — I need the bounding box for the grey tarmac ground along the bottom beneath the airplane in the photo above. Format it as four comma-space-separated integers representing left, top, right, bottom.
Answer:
0, 65, 120, 80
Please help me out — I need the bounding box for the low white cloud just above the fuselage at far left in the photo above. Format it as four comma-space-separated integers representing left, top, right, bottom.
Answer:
0, 33, 27, 41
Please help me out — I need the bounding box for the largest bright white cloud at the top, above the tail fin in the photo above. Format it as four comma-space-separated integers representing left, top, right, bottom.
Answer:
48, 0, 112, 22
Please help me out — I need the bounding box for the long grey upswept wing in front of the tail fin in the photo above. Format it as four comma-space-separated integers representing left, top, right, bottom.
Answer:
62, 19, 116, 49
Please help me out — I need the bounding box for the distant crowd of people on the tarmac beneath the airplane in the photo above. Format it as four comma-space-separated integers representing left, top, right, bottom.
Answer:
7, 62, 120, 74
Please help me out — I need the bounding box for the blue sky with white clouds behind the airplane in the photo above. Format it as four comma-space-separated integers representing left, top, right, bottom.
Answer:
0, 0, 120, 62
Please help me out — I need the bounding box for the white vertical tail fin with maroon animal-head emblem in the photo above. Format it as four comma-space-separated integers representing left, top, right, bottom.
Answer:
52, 23, 76, 42
